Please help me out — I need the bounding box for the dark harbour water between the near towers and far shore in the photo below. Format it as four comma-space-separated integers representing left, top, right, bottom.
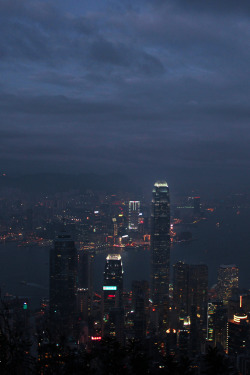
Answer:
0, 209, 250, 306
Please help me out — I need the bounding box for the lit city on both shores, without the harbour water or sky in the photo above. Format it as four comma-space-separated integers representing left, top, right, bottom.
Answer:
0, 180, 250, 375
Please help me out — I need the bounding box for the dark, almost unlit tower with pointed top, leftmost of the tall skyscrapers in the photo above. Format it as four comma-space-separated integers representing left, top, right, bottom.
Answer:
50, 232, 77, 328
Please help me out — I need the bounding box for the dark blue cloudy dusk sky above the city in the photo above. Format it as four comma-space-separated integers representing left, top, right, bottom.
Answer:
0, 0, 250, 189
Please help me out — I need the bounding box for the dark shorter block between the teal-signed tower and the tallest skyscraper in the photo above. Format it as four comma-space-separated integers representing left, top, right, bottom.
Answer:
132, 280, 149, 339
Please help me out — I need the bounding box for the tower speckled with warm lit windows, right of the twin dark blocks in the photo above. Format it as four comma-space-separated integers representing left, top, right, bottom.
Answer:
217, 264, 239, 304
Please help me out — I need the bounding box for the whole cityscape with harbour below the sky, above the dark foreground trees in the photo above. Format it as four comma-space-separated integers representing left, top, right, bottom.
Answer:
0, 180, 250, 375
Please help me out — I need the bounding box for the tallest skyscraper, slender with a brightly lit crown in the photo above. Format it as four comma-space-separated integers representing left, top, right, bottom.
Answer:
151, 181, 170, 336
